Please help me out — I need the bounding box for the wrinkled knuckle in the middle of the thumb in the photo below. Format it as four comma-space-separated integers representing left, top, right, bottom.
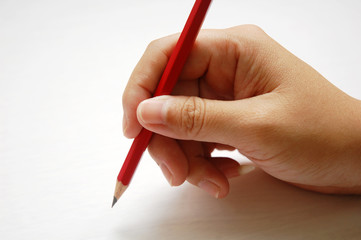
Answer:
180, 97, 206, 137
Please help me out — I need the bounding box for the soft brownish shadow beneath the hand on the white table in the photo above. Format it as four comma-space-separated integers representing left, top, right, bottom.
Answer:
115, 170, 361, 240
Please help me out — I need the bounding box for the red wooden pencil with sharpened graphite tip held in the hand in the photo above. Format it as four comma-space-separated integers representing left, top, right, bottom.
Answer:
112, 0, 211, 207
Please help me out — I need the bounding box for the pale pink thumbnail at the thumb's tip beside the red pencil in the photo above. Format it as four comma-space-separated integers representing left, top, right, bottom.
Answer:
137, 96, 166, 124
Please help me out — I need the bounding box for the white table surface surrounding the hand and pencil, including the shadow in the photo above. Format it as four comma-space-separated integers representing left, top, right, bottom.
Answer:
0, 0, 361, 240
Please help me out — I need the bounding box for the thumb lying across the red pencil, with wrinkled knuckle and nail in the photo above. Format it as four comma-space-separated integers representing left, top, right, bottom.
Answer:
137, 96, 272, 148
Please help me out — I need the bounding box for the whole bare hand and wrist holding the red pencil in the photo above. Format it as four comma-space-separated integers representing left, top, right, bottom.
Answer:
123, 25, 361, 198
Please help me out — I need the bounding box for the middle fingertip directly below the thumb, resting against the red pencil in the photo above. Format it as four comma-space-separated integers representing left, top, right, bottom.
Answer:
148, 134, 188, 186
